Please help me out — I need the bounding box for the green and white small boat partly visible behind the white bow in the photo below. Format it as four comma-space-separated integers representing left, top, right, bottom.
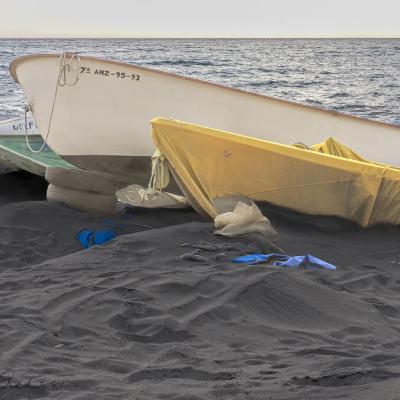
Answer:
0, 134, 75, 176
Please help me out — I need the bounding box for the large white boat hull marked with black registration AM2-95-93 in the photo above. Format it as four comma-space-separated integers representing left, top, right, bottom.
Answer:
10, 55, 400, 183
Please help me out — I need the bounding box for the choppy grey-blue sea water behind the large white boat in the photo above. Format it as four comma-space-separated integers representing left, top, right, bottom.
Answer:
0, 39, 400, 125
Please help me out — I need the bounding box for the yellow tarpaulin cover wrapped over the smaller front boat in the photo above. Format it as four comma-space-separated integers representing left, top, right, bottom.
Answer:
151, 118, 400, 227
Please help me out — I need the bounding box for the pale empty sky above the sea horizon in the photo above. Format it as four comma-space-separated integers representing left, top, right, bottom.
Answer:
0, 0, 400, 37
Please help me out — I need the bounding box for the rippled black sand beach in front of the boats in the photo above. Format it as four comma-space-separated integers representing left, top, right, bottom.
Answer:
0, 174, 400, 400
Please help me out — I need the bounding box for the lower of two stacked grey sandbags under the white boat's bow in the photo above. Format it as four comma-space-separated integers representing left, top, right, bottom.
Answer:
47, 184, 117, 215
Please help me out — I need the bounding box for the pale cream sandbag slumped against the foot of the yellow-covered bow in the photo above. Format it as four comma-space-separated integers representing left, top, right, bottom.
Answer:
214, 201, 277, 243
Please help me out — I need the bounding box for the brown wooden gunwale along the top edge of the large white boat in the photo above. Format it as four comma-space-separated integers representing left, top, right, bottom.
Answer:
9, 53, 400, 132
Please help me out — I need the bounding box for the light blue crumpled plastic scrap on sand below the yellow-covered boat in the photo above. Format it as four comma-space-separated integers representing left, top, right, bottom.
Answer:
232, 253, 336, 270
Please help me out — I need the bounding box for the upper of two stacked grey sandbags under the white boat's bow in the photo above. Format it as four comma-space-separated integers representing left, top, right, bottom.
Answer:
46, 167, 129, 195
